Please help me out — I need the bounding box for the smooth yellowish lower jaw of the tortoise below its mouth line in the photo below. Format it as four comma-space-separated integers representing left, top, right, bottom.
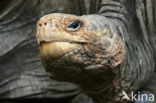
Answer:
39, 41, 86, 59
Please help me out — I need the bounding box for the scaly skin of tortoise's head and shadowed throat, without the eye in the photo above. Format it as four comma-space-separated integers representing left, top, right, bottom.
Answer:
36, 14, 130, 103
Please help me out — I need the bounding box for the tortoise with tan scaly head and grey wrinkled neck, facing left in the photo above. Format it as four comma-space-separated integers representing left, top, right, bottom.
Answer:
36, 0, 156, 103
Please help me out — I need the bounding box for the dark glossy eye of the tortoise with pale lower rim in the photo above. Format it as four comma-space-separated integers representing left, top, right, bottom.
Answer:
67, 20, 81, 31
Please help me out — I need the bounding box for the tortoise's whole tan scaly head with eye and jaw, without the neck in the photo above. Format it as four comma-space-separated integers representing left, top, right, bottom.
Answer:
36, 13, 125, 83
